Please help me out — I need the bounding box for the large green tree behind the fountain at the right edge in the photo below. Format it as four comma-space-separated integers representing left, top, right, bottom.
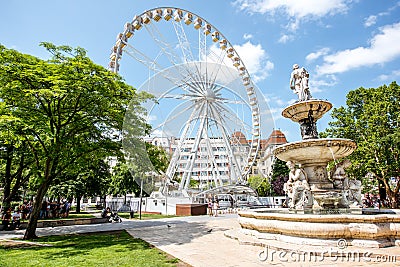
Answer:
322, 82, 400, 207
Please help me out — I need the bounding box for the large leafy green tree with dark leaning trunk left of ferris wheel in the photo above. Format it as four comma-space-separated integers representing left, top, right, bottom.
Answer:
0, 43, 148, 239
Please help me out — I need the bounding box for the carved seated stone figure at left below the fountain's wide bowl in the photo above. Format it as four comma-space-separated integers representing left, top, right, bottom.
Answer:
283, 161, 310, 209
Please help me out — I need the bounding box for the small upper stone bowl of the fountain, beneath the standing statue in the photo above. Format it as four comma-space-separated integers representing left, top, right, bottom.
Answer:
282, 99, 332, 122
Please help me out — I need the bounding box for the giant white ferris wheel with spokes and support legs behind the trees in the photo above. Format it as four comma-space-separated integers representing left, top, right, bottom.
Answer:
109, 7, 270, 196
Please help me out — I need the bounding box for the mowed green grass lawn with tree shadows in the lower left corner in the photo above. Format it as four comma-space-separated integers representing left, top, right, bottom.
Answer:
0, 231, 181, 267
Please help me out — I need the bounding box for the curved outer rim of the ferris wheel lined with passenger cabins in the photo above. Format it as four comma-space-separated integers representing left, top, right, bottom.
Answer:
109, 6, 261, 176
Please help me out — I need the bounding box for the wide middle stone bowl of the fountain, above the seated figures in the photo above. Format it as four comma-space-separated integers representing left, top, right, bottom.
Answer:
273, 138, 357, 165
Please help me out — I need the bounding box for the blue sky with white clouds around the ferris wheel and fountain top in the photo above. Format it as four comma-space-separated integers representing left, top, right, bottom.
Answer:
0, 0, 400, 141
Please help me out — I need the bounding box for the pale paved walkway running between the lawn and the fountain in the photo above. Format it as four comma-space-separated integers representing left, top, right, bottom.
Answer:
0, 214, 400, 267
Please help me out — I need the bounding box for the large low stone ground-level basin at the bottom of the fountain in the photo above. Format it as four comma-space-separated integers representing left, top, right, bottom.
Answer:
239, 209, 400, 247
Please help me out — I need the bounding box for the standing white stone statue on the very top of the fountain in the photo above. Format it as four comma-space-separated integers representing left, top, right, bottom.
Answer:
290, 64, 312, 101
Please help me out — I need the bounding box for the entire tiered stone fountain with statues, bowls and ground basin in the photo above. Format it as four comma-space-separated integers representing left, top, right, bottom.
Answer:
239, 64, 400, 247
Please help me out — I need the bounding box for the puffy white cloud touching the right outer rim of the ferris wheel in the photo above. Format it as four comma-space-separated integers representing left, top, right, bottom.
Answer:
233, 41, 274, 82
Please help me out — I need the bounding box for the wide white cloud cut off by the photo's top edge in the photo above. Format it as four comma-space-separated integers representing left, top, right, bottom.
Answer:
234, 0, 352, 19
